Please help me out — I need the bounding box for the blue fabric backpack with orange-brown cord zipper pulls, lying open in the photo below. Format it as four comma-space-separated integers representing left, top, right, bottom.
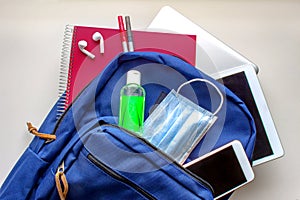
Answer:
0, 52, 256, 199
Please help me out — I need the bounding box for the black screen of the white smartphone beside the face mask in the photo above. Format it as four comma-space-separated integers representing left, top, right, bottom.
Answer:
186, 141, 250, 198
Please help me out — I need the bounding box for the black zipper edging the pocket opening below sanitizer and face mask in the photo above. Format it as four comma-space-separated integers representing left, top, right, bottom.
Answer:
101, 124, 214, 193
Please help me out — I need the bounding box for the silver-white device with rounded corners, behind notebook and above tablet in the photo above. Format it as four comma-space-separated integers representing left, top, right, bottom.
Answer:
148, 6, 259, 75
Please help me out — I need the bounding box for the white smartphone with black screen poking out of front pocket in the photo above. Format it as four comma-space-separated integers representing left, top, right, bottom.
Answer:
183, 140, 254, 199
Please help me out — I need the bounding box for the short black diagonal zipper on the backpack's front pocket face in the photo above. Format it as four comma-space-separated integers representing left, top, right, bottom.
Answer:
87, 154, 156, 200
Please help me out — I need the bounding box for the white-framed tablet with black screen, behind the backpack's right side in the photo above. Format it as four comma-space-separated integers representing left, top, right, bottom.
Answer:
212, 64, 284, 165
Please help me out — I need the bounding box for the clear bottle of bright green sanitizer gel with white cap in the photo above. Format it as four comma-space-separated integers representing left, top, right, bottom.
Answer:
119, 70, 146, 135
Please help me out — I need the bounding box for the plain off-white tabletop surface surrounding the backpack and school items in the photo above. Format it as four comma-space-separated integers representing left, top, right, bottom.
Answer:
0, 0, 300, 200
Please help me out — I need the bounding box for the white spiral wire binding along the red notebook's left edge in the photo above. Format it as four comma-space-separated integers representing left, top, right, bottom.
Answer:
56, 25, 74, 119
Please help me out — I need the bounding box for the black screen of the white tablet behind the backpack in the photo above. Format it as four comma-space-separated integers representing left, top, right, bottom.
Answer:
218, 72, 273, 160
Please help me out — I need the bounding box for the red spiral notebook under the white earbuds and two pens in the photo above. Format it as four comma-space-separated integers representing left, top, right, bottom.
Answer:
57, 25, 196, 118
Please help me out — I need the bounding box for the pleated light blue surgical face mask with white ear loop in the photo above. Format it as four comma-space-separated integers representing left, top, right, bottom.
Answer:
143, 79, 223, 164
